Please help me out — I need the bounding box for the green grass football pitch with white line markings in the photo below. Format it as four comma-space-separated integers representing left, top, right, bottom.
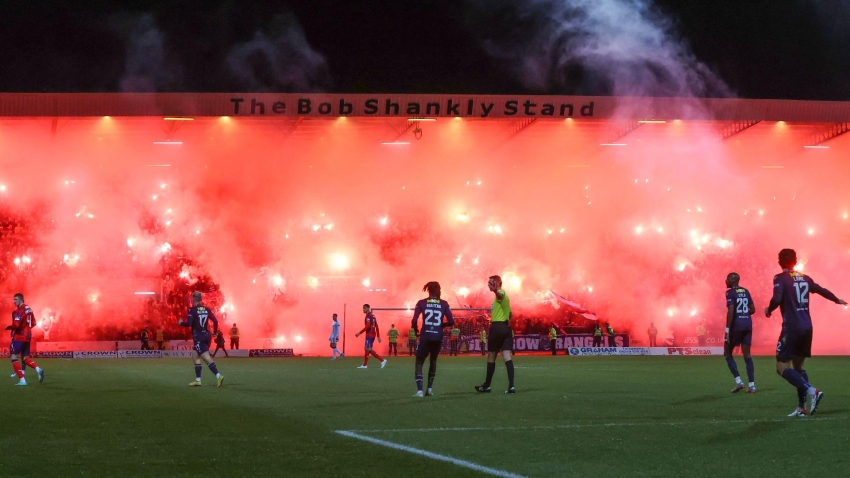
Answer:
0, 356, 850, 478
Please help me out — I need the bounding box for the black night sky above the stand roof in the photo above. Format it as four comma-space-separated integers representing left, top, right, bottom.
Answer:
0, 0, 850, 100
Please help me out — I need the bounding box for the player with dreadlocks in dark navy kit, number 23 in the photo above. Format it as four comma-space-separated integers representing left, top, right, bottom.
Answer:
411, 281, 455, 397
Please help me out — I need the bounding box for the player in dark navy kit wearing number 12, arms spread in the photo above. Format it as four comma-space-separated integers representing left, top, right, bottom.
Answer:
764, 249, 847, 417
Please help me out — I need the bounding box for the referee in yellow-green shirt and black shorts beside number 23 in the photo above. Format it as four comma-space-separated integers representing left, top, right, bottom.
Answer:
475, 276, 516, 393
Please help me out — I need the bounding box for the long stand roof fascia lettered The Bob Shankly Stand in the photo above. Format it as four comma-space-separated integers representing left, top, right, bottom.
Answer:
0, 93, 850, 122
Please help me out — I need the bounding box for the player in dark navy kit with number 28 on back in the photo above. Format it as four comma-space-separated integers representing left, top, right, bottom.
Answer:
723, 272, 756, 393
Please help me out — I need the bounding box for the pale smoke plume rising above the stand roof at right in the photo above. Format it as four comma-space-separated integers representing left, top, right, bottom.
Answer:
468, 0, 732, 97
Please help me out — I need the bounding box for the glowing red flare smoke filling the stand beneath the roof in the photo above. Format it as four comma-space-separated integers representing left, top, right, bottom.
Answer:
0, 118, 850, 353
